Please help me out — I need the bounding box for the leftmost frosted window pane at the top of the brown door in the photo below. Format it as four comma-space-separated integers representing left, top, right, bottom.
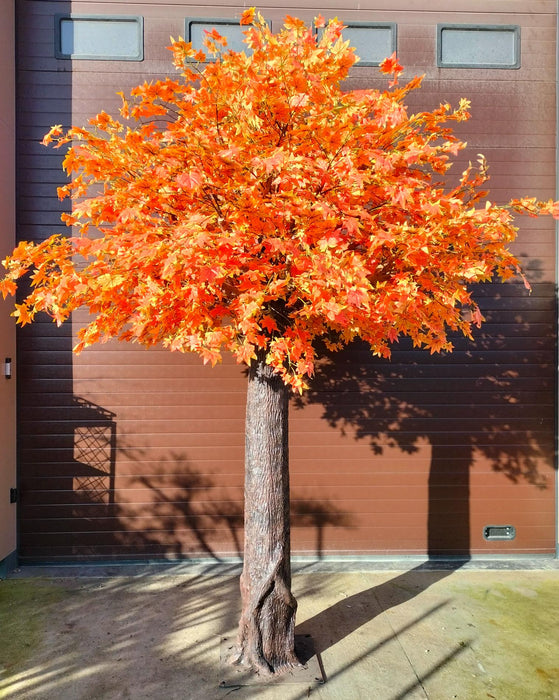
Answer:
58, 17, 143, 61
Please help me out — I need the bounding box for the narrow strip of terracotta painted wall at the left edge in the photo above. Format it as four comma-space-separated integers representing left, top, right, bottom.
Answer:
0, 0, 16, 561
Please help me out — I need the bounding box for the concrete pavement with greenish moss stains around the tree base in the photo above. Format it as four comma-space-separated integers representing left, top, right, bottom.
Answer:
0, 562, 559, 700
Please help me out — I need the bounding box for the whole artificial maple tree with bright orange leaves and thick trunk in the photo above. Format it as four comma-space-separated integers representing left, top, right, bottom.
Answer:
0, 9, 559, 673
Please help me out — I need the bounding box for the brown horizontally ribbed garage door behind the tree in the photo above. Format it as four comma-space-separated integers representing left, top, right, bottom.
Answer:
18, 0, 556, 561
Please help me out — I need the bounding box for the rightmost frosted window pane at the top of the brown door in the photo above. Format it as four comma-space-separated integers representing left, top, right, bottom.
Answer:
439, 27, 520, 68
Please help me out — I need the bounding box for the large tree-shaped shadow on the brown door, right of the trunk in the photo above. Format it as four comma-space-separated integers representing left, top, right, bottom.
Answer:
295, 283, 555, 558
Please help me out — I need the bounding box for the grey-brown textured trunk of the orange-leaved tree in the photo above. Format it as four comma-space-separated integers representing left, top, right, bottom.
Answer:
235, 353, 300, 674
